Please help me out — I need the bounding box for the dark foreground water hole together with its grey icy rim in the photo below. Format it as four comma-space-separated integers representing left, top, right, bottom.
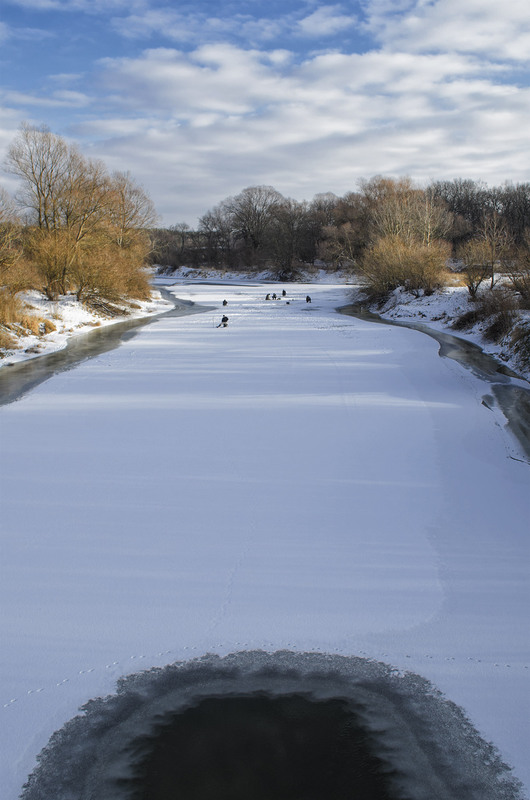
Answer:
21, 651, 522, 800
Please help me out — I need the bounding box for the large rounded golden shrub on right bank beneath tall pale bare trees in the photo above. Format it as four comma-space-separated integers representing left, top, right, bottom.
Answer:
360, 236, 450, 295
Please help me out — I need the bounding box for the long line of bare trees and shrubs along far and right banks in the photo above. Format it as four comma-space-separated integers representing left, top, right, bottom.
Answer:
153, 176, 530, 296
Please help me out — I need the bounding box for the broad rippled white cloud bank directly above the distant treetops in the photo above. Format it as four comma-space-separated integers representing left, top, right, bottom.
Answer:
63, 44, 530, 224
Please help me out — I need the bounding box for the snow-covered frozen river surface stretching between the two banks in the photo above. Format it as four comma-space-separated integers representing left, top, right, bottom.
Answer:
0, 286, 530, 800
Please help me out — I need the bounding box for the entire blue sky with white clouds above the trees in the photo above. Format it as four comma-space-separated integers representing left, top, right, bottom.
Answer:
0, 0, 530, 226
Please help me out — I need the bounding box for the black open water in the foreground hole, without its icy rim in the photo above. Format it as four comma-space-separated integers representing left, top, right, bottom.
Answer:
118, 692, 396, 800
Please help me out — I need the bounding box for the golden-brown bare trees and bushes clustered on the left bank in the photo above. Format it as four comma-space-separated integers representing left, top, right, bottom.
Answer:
0, 124, 157, 348
